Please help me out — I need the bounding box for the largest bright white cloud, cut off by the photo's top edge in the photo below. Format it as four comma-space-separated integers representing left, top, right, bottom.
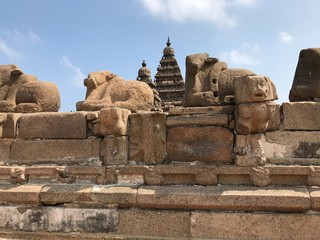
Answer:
140, 0, 256, 27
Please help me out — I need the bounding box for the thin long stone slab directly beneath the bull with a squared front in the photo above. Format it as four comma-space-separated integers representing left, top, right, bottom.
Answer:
169, 105, 234, 116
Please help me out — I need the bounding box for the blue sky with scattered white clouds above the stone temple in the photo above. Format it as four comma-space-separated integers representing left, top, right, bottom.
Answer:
0, 0, 320, 112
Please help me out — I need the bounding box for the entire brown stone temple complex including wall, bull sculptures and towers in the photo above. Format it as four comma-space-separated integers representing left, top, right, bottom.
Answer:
0, 47, 320, 240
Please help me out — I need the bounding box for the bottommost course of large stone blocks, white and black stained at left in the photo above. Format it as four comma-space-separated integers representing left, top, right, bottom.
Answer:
0, 206, 320, 240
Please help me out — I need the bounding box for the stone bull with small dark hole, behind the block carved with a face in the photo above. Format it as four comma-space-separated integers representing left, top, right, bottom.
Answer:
183, 53, 253, 107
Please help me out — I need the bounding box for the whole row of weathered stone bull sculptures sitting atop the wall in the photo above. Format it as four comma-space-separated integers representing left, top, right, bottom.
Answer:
0, 48, 320, 113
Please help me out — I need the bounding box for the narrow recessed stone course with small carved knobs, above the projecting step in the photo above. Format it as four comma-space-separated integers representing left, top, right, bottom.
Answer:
0, 164, 320, 186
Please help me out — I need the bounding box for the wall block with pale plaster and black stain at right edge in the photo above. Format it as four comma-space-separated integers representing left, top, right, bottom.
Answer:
261, 131, 320, 165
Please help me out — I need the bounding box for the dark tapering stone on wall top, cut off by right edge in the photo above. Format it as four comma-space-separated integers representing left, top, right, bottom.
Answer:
289, 48, 320, 102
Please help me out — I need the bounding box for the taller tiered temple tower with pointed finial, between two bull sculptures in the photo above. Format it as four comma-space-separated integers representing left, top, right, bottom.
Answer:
155, 38, 185, 109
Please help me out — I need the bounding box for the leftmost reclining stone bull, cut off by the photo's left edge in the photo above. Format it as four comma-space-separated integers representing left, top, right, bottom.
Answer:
0, 65, 60, 112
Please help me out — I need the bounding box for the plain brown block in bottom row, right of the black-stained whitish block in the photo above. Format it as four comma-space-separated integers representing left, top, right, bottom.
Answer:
118, 210, 190, 239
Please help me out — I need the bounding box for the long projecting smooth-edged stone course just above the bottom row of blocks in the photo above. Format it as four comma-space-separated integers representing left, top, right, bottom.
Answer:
0, 184, 320, 212
